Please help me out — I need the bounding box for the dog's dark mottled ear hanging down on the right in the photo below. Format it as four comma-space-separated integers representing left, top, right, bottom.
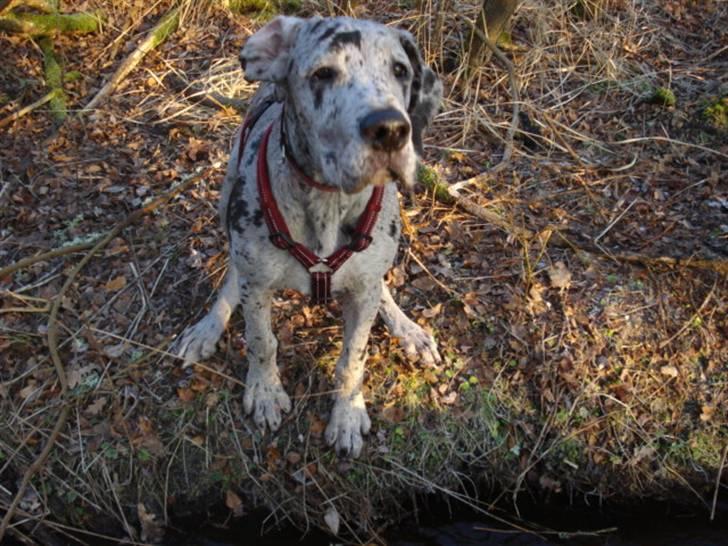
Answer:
398, 30, 442, 155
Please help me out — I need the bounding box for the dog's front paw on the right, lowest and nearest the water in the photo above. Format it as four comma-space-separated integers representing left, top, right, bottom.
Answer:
326, 393, 372, 457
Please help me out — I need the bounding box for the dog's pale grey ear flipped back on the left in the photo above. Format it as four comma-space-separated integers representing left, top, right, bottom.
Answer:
240, 15, 303, 82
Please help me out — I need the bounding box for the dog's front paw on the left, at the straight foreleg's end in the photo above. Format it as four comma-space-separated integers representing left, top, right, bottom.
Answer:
243, 368, 291, 430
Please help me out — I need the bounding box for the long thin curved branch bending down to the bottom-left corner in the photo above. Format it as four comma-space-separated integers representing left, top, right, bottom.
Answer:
0, 175, 202, 544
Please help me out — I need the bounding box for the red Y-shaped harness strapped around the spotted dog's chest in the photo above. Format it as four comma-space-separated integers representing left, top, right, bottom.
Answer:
240, 110, 384, 305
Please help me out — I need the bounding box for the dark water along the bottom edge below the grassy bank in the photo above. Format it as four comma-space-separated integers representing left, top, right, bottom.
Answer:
172, 505, 728, 546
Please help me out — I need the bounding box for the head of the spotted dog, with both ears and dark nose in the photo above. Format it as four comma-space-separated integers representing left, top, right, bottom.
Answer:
240, 16, 442, 193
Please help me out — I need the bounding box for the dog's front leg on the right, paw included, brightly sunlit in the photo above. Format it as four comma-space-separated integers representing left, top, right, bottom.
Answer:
326, 283, 381, 457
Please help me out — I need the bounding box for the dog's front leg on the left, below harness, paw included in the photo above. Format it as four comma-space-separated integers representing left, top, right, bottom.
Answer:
243, 289, 291, 430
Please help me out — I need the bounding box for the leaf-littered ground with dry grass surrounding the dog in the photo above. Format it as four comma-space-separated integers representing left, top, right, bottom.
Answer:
0, 0, 728, 542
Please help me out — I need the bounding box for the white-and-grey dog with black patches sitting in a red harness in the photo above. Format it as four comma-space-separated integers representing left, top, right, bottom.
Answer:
174, 16, 442, 457
